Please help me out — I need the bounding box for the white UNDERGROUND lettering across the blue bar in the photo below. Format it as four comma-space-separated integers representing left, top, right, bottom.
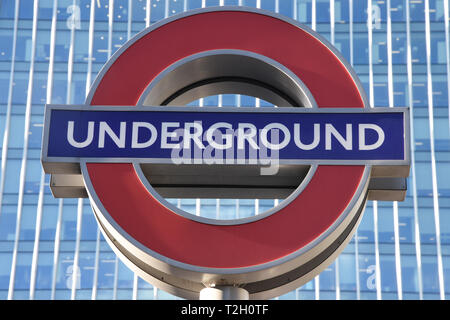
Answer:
63, 121, 386, 156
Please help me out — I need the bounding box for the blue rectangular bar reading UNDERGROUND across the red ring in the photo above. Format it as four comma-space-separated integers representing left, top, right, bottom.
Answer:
44, 107, 406, 162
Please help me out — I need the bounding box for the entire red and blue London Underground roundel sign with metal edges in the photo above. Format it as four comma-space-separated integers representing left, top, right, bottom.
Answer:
42, 7, 409, 299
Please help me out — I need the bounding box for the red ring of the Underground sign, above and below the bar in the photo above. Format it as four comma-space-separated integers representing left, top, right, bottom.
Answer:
82, 7, 371, 298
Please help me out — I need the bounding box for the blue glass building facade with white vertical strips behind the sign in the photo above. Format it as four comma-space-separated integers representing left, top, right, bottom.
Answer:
0, 0, 450, 299
